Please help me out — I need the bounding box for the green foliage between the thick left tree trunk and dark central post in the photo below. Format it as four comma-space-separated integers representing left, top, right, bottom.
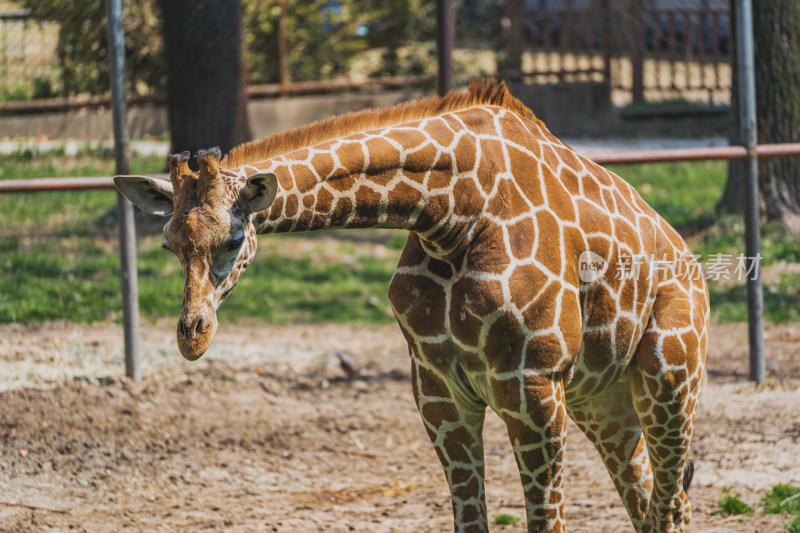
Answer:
242, 0, 436, 83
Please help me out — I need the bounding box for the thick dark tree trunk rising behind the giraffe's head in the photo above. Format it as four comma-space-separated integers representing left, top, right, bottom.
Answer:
159, 0, 250, 157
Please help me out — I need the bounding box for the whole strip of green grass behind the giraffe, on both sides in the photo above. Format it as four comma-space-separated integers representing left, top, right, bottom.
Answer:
0, 153, 800, 323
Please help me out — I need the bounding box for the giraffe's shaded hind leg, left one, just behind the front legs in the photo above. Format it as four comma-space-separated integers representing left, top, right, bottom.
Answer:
568, 380, 653, 531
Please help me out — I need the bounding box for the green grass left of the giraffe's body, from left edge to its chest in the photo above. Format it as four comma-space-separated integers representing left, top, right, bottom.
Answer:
0, 149, 398, 323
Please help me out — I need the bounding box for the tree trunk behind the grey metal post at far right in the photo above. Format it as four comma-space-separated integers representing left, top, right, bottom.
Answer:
717, 0, 800, 227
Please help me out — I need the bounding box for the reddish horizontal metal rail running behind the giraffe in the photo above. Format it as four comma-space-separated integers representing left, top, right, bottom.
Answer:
0, 143, 800, 193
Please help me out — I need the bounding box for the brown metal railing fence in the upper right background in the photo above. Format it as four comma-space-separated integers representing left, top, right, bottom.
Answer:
501, 0, 731, 106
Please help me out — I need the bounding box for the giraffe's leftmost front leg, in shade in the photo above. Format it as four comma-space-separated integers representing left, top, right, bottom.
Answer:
411, 358, 489, 533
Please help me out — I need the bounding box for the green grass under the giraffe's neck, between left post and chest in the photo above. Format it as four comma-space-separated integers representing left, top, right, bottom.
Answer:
134, 235, 394, 324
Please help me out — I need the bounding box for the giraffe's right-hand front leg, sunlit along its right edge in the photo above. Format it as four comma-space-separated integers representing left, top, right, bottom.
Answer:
493, 376, 567, 533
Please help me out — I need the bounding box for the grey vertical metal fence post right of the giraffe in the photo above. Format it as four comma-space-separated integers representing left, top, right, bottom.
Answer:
736, 0, 764, 383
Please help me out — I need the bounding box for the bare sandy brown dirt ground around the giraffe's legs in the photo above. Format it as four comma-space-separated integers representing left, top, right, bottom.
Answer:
0, 323, 800, 532
